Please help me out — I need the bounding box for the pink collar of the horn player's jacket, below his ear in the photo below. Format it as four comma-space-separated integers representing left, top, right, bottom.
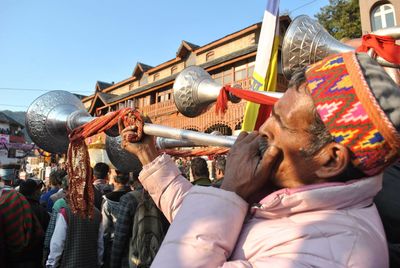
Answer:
252, 174, 382, 219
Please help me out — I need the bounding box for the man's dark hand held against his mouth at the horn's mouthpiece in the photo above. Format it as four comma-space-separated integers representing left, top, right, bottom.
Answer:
221, 131, 281, 205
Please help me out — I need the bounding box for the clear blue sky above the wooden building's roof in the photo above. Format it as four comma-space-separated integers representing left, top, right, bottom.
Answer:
0, 0, 328, 111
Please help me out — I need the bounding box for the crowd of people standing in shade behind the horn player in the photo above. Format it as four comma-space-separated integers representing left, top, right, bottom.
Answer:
0, 156, 225, 268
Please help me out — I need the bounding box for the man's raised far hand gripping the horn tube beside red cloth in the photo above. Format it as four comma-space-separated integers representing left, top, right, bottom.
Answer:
120, 127, 158, 165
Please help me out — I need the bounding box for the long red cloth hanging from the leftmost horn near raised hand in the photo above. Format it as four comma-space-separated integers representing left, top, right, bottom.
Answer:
67, 108, 143, 218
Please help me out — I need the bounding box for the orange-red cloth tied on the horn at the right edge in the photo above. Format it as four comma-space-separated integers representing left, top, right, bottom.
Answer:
356, 34, 400, 64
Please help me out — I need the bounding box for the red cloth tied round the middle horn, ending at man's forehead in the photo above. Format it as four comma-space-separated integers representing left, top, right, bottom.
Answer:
215, 85, 278, 114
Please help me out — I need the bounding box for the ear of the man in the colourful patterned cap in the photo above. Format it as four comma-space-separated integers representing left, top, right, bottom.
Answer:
315, 142, 350, 179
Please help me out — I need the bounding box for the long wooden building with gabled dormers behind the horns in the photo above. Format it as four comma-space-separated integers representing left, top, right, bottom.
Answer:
82, 16, 291, 135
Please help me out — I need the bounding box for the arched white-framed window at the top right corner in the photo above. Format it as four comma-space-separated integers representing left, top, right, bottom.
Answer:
371, 4, 396, 31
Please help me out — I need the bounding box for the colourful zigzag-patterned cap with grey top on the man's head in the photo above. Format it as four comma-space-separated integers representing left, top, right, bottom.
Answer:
306, 52, 400, 176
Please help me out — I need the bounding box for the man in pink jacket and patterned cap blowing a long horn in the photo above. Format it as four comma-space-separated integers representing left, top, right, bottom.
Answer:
122, 49, 400, 268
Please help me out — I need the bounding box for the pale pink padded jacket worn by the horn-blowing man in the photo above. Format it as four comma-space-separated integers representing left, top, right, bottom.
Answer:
140, 155, 388, 268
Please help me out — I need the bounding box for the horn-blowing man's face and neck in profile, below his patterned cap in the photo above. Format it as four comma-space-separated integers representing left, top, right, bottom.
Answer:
259, 86, 316, 188
